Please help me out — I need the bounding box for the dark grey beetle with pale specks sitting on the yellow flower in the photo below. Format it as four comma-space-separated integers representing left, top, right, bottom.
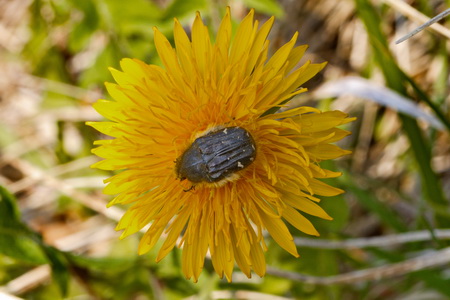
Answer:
175, 126, 256, 183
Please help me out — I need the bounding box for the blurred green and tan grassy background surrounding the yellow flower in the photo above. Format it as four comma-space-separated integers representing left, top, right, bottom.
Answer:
0, 0, 450, 300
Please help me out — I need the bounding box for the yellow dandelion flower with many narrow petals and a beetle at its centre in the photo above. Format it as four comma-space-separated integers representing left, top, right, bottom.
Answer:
88, 9, 353, 281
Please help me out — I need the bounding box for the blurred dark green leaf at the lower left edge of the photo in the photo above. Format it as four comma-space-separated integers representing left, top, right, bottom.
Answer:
0, 186, 47, 264
